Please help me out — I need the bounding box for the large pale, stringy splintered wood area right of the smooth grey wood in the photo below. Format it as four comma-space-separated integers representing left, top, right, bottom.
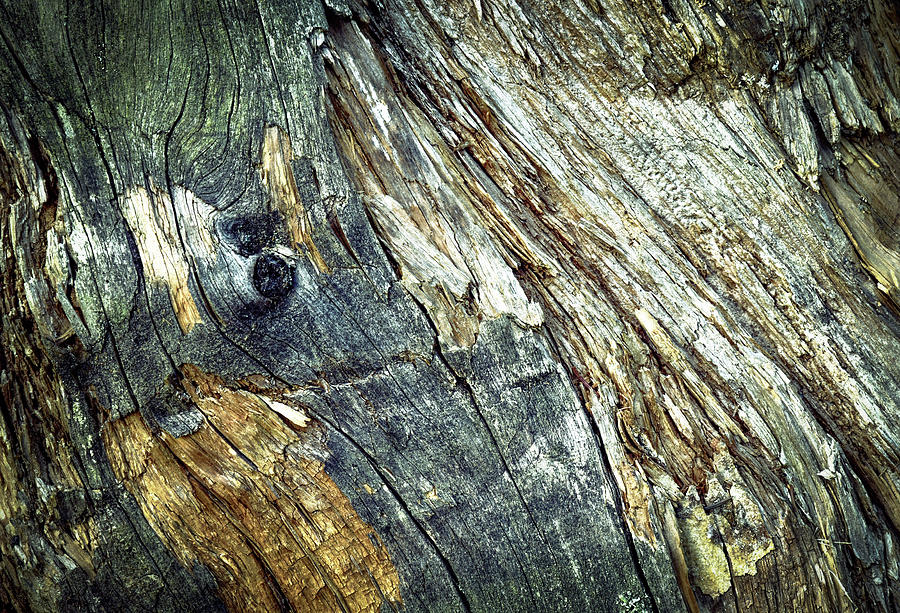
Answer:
325, 2, 900, 610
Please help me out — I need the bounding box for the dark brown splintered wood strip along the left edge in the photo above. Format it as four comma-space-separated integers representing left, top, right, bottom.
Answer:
0, 140, 103, 596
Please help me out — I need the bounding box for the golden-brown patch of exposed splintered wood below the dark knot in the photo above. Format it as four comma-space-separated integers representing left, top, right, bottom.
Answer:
103, 365, 401, 613
